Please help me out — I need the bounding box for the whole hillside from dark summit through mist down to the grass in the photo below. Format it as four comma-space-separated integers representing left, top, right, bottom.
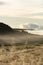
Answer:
0, 23, 43, 45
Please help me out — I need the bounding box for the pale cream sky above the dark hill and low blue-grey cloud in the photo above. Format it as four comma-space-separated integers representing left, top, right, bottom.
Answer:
0, 0, 43, 27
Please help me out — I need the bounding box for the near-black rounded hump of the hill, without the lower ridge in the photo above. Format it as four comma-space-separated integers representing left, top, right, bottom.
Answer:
0, 22, 13, 34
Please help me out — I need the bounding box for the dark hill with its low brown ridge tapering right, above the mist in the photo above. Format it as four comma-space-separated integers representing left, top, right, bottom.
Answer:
0, 22, 28, 34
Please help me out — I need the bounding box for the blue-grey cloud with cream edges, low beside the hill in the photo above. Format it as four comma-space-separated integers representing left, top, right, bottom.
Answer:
19, 23, 43, 30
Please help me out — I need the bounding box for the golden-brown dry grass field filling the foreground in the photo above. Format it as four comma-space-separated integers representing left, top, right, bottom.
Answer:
0, 45, 43, 65
